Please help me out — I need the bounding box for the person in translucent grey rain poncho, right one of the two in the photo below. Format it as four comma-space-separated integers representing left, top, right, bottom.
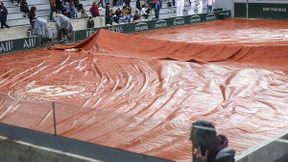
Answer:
56, 14, 73, 42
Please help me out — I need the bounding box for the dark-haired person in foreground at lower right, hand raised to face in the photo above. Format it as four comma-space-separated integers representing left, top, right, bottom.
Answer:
190, 120, 235, 162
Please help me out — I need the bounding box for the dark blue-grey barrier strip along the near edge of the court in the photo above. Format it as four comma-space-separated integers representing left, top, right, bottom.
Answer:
0, 123, 170, 162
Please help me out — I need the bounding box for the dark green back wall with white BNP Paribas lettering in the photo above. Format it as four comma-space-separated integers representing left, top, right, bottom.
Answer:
234, 0, 288, 20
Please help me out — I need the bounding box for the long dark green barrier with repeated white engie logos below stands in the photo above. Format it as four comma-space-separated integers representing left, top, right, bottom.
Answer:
75, 10, 231, 41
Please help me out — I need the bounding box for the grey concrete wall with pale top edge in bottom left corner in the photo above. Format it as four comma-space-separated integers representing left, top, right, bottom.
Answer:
0, 136, 99, 162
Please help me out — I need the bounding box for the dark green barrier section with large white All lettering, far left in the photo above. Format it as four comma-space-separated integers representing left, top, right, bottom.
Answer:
0, 37, 40, 55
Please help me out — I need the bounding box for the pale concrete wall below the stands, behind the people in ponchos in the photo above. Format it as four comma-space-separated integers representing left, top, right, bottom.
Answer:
0, 17, 105, 41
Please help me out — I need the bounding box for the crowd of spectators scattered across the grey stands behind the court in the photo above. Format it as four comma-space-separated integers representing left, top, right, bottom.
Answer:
0, 0, 215, 29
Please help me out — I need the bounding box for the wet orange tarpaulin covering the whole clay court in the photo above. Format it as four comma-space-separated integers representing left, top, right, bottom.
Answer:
0, 19, 288, 161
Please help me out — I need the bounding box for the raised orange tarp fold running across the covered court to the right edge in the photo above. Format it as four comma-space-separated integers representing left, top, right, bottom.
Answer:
49, 29, 288, 65
